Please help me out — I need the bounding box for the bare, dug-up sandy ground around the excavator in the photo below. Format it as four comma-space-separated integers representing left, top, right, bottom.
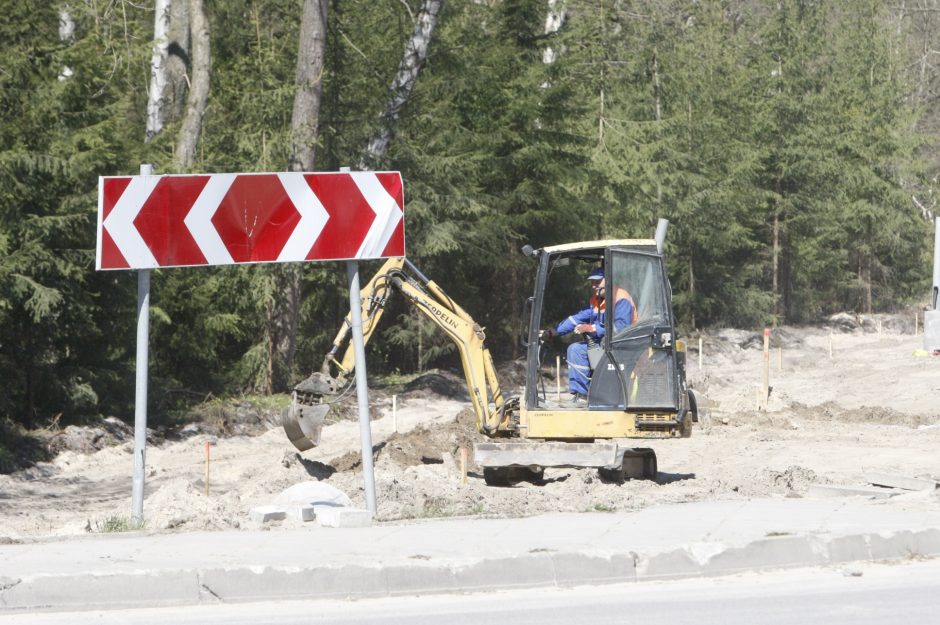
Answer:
0, 316, 940, 542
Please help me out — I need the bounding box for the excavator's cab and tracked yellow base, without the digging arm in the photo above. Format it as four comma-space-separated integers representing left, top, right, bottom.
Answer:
474, 234, 697, 484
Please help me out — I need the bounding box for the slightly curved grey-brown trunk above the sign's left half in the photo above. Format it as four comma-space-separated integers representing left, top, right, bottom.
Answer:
176, 0, 211, 170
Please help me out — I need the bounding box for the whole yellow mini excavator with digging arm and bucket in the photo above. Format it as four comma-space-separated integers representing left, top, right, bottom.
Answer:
282, 222, 698, 485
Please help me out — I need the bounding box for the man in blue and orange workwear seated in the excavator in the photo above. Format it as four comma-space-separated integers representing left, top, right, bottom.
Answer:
545, 267, 637, 405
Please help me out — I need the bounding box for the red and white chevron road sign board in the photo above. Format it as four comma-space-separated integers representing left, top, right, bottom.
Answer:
97, 172, 405, 269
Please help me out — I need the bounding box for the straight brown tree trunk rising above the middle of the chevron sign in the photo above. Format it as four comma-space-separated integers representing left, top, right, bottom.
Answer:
288, 0, 329, 171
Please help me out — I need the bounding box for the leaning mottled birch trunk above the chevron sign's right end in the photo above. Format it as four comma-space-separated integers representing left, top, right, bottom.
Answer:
359, 0, 444, 169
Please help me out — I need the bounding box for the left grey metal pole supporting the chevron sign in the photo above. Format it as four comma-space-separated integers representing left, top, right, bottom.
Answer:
131, 165, 153, 525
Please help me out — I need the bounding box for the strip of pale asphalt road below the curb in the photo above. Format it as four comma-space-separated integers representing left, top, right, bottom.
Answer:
12, 560, 940, 625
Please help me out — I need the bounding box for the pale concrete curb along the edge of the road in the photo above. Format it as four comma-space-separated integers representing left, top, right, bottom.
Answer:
0, 529, 940, 614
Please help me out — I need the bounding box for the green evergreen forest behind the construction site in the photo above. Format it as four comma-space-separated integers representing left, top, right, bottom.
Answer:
0, 0, 940, 450
